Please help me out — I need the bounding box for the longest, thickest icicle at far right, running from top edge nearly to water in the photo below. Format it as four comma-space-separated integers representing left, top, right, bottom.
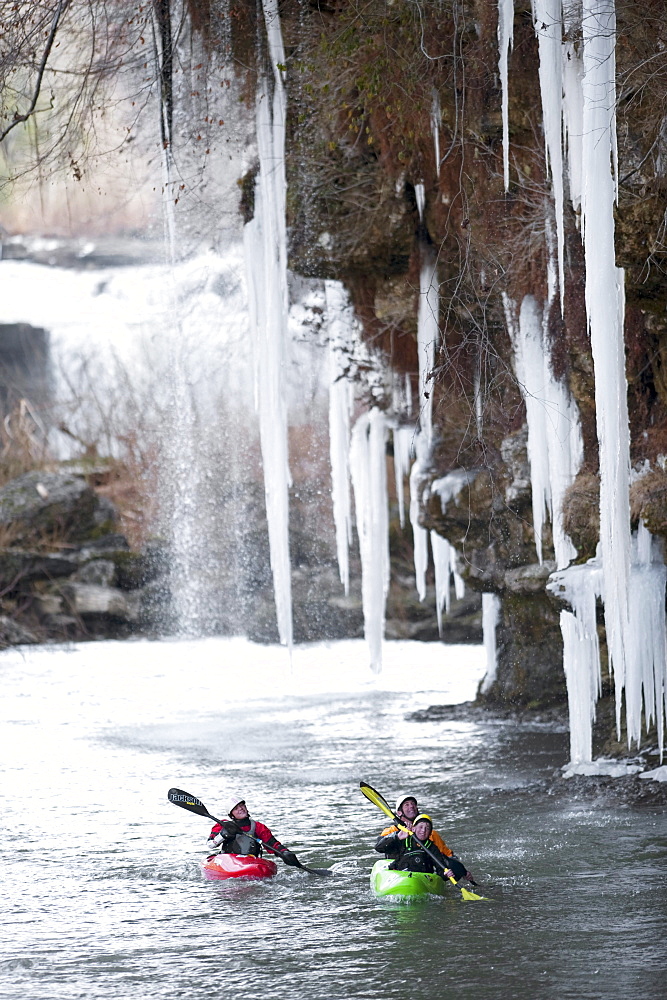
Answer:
581, 0, 630, 732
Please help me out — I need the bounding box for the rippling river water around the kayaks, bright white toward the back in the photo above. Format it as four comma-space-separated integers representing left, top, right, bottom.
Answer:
0, 639, 667, 1000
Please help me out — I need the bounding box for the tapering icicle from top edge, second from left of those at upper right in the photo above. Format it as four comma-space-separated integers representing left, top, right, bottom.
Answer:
532, 0, 565, 315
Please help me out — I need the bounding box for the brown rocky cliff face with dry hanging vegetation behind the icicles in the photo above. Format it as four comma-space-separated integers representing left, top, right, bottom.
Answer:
268, 0, 667, 704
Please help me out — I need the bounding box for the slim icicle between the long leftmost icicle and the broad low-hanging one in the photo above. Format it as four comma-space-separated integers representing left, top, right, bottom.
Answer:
325, 281, 353, 594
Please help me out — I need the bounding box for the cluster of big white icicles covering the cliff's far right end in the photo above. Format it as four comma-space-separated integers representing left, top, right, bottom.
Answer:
498, 0, 666, 767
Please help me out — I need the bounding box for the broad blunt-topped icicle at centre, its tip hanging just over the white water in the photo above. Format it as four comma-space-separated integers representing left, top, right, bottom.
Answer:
350, 409, 389, 673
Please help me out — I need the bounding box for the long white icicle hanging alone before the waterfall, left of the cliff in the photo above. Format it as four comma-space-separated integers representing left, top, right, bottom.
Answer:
244, 0, 292, 649
